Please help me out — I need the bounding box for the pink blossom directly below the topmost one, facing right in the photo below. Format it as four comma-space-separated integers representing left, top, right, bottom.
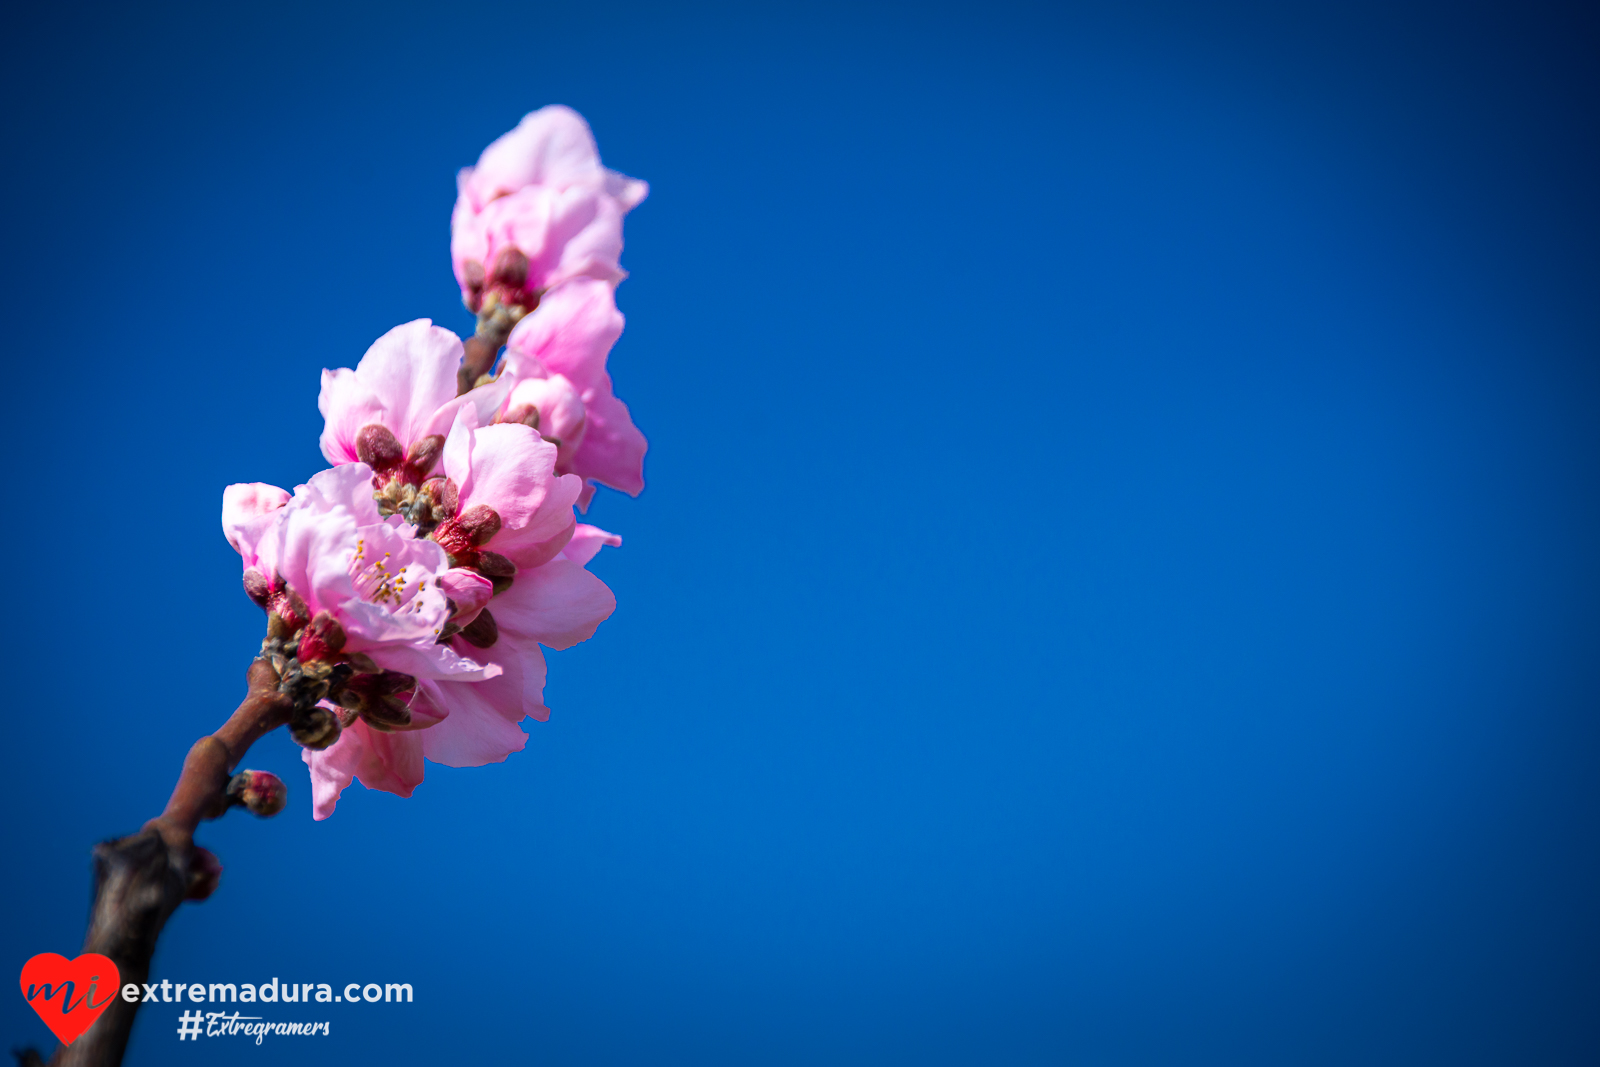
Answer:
501, 278, 646, 506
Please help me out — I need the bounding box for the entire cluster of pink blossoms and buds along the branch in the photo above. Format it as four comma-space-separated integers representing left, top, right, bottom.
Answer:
222, 107, 646, 819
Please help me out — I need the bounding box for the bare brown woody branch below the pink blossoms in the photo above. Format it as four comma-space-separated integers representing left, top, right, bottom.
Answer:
36, 659, 293, 1067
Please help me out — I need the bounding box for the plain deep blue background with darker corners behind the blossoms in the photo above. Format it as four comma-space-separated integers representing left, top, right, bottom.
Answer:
0, 3, 1600, 1065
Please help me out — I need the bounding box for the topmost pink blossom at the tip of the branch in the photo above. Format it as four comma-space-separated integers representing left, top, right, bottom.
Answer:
450, 104, 650, 312
